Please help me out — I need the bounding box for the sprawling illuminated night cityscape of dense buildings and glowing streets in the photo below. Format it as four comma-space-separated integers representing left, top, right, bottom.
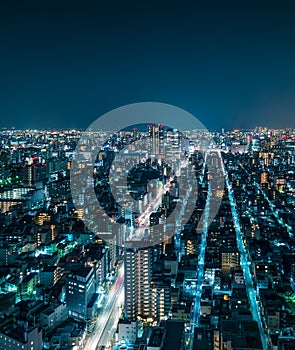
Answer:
0, 125, 295, 350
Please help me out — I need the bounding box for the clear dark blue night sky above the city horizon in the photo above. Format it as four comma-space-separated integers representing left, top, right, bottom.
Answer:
0, 0, 295, 129
